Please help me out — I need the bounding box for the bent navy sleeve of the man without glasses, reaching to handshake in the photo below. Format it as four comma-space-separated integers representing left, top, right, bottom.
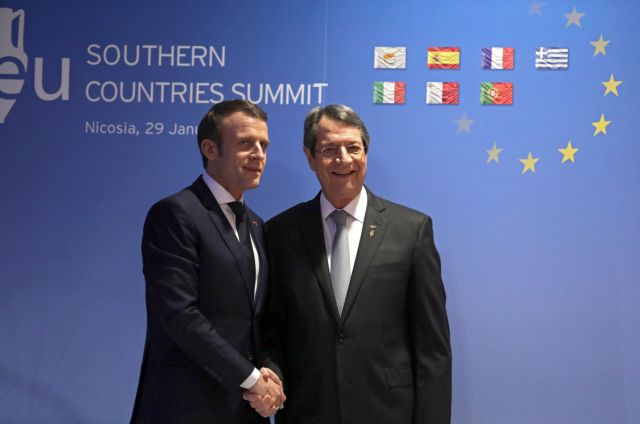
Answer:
142, 201, 254, 391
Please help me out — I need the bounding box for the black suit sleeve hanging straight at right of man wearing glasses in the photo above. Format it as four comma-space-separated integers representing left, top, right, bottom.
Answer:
407, 217, 451, 424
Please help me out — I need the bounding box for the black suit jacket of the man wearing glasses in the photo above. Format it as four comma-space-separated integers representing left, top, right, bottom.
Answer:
263, 190, 451, 424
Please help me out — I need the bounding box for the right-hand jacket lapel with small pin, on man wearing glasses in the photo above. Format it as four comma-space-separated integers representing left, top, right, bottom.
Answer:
340, 189, 389, 324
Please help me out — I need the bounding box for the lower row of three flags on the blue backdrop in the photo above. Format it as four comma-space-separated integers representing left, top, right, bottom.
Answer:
373, 81, 513, 105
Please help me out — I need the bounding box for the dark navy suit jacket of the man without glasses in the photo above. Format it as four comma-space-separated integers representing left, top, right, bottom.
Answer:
131, 177, 267, 424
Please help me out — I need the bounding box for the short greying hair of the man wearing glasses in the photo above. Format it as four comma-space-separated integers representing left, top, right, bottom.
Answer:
304, 104, 369, 157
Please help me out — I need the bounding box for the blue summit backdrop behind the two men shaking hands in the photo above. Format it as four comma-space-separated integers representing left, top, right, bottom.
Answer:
0, 0, 640, 424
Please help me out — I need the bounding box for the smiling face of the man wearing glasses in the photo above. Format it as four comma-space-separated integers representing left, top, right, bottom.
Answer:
304, 116, 367, 209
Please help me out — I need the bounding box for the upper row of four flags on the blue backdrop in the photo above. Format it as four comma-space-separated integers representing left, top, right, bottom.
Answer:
373, 47, 569, 69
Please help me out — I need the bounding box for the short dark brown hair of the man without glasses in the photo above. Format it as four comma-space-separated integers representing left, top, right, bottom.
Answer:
198, 99, 267, 168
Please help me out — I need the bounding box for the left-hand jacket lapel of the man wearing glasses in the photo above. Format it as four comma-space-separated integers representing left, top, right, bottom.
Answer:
298, 194, 340, 321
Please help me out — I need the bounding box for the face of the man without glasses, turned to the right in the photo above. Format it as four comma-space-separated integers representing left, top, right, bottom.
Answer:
201, 112, 269, 199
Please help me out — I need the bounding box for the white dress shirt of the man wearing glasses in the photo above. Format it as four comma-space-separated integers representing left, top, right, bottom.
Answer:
320, 186, 368, 272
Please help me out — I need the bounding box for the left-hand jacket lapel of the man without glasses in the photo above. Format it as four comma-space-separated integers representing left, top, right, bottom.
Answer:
191, 177, 255, 308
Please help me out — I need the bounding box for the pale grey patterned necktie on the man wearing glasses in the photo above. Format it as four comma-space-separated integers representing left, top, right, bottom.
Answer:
330, 209, 351, 315
